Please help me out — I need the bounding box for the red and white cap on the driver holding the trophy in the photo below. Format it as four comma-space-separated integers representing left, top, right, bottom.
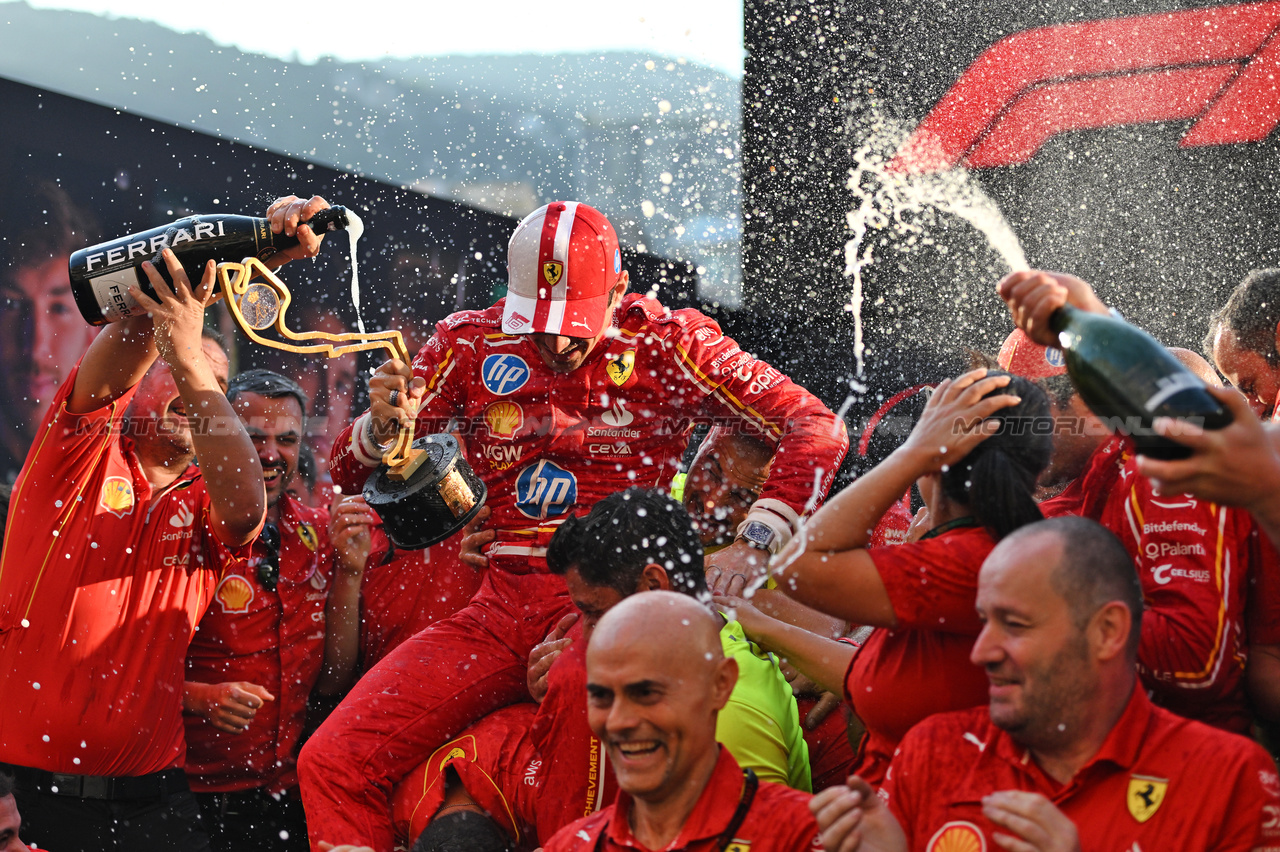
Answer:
502, 201, 622, 338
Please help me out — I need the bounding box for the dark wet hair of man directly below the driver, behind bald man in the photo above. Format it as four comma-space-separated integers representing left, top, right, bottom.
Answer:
547, 487, 707, 596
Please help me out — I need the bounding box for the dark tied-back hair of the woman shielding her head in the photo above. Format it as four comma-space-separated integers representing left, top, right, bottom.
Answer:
942, 370, 1053, 541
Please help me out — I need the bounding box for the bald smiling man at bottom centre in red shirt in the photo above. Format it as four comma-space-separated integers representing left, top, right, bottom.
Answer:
545, 591, 822, 852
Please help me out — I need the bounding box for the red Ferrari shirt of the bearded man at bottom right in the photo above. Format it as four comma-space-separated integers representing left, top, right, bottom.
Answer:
881, 687, 1280, 852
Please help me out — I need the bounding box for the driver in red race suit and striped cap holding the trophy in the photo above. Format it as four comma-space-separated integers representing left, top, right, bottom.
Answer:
268, 196, 849, 852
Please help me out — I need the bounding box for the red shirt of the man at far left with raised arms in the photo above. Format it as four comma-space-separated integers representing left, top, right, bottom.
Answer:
0, 366, 247, 775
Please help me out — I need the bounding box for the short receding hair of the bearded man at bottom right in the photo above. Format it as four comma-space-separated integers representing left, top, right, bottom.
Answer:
1015, 514, 1143, 659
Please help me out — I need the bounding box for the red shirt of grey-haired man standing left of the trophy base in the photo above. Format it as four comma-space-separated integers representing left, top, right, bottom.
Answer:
186, 495, 333, 793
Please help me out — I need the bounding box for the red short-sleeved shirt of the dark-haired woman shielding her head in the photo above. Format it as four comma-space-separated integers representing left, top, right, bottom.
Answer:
845, 527, 996, 785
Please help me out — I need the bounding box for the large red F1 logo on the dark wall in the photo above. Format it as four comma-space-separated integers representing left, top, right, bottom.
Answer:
888, 3, 1280, 173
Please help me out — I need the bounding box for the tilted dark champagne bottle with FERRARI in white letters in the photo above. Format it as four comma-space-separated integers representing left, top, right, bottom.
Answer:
68, 207, 358, 325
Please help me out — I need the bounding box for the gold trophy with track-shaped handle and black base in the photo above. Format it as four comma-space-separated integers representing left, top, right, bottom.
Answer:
218, 257, 488, 550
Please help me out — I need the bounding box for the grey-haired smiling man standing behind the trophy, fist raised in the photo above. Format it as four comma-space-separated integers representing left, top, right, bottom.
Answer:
183, 370, 370, 851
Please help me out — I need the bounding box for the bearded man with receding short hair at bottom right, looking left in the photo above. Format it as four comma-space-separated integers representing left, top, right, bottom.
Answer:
812, 517, 1280, 852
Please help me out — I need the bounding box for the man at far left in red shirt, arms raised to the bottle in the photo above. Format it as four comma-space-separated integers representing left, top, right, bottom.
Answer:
0, 248, 265, 852
